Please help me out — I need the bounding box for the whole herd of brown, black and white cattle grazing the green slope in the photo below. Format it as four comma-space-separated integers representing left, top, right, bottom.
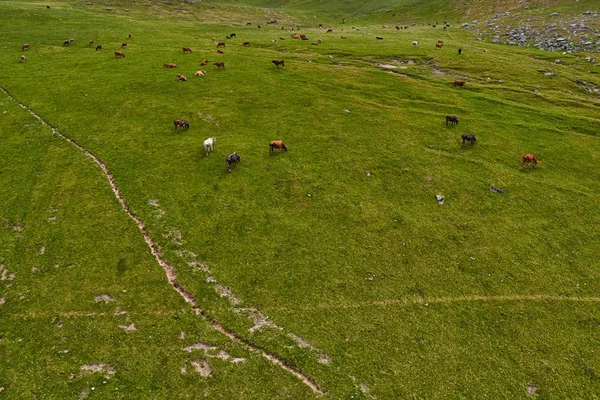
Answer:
20, 21, 537, 172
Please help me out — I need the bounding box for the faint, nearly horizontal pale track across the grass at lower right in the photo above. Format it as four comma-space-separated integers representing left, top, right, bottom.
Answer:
262, 294, 600, 312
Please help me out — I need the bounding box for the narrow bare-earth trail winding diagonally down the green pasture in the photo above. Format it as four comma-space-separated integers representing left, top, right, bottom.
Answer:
0, 86, 326, 396
